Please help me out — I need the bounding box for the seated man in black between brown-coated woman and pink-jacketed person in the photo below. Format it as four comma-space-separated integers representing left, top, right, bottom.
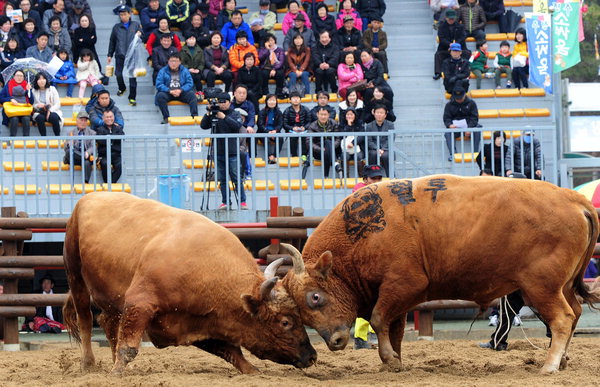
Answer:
311, 31, 339, 93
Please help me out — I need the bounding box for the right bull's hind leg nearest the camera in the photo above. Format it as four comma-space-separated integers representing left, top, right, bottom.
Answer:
523, 286, 577, 373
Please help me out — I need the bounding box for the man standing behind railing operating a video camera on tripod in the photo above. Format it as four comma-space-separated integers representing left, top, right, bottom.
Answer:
200, 92, 248, 210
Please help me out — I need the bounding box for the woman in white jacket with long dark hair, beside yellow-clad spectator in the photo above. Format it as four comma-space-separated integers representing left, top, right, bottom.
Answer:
33, 72, 63, 136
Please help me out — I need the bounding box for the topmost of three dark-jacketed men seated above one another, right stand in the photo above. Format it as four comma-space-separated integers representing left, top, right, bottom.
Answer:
433, 9, 471, 80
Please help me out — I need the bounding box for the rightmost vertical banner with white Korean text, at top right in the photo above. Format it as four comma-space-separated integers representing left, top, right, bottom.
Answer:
552, 0, 581, 73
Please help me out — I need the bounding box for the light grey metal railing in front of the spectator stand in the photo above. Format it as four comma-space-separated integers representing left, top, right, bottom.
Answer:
0, 127, 557, 216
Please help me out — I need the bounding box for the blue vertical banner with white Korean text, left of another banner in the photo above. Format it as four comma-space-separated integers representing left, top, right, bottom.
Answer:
525, 12, 552, 94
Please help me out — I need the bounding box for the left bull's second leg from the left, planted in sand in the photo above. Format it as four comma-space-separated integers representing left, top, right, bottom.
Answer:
111, 293, 156, 374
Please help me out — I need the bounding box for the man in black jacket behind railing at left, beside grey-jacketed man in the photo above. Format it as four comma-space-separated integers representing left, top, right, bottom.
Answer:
96, 110, 125, 183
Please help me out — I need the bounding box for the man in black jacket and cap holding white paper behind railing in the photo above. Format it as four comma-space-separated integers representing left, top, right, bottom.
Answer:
444, 86, 481, 161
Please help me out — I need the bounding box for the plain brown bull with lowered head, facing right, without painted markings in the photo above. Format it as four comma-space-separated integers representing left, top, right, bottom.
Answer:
64, 192, 316, 373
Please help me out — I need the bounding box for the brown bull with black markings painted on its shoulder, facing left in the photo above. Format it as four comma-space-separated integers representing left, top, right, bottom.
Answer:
284, 175, 600, 372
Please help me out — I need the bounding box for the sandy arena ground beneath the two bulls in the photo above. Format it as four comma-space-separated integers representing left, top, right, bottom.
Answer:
0, 338, 600, 387
